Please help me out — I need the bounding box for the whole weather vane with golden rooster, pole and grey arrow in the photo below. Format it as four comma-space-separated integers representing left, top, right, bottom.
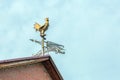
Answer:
30, 18, 65, 56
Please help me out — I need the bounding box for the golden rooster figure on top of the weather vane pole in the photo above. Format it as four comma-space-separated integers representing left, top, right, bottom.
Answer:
34, 18, 49, 37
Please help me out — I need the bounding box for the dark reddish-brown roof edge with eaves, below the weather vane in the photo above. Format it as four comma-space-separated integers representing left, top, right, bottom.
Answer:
0, 55, 63, 80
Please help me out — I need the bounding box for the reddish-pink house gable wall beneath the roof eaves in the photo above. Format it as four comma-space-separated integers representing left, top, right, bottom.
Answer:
0, 63, 52, 80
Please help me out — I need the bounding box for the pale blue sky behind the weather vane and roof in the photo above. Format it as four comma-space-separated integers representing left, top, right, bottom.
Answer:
0, 0, 120, 80
